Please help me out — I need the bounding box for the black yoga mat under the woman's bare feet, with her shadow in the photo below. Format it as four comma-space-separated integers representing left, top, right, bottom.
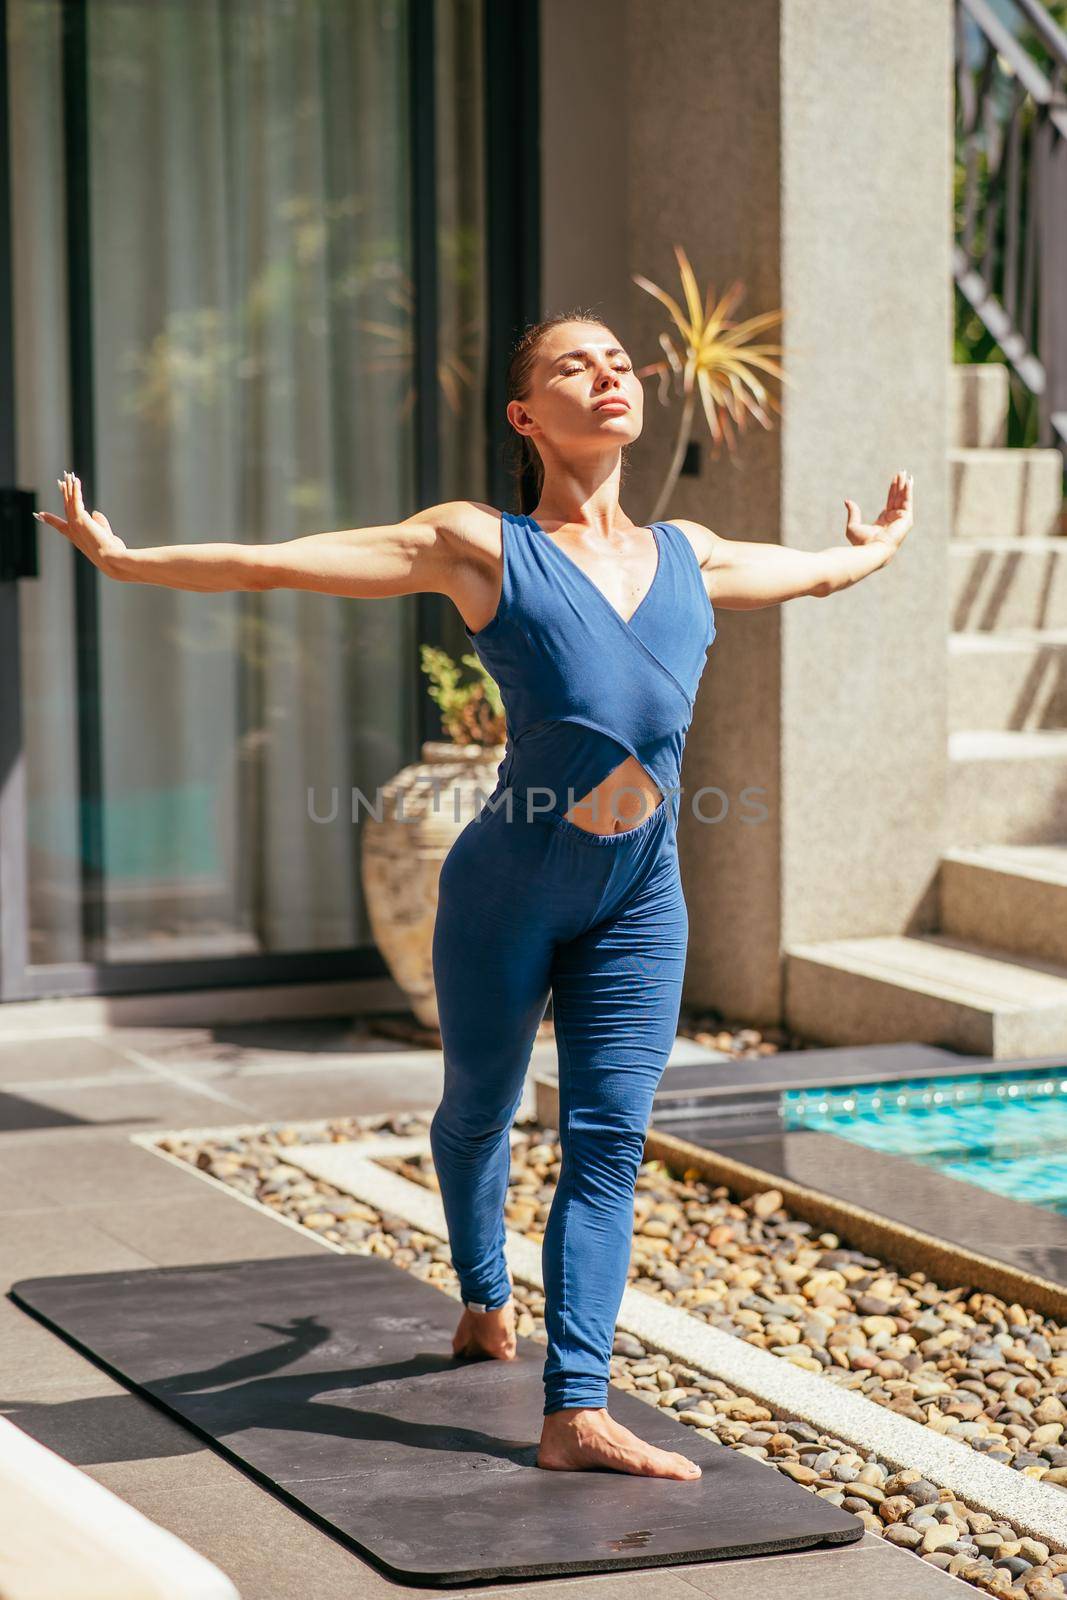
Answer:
11, 1254, 864, 1586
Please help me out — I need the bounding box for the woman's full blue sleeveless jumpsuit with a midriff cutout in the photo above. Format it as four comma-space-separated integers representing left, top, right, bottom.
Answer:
430, 512, 715, 1413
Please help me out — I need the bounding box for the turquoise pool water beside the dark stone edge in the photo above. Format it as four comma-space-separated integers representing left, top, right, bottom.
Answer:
782, 1062, 1067, 1216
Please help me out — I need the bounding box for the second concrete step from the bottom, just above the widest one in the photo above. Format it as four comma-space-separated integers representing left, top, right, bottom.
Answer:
937, 838, 1067, 966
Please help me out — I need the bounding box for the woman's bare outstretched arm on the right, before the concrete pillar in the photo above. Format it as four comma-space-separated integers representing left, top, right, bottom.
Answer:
684, 472, 912, 611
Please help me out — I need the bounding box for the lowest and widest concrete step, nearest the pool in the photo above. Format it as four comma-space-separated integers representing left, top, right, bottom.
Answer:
785, 933, 1067, 1061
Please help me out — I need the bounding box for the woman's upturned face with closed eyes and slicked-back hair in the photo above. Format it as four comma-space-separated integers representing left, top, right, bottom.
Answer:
507, 322, 645, 456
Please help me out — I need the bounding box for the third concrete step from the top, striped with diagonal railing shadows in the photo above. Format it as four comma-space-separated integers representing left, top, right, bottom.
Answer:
949, 538, 1067, 634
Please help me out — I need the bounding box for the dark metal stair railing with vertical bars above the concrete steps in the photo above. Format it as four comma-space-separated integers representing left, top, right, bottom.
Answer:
953, 0, 1067, 464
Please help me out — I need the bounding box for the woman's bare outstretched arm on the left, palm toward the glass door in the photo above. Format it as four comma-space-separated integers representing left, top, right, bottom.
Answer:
37, 472, 491, 598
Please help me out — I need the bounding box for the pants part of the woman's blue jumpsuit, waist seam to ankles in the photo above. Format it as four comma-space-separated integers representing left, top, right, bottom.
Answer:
430, 797, 689, 1413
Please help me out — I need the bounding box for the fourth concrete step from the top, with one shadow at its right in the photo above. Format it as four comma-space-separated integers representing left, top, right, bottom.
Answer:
949, 627, 1067, 733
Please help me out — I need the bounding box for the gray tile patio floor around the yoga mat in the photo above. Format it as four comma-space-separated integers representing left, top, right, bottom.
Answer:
0, 1022, 974, 1600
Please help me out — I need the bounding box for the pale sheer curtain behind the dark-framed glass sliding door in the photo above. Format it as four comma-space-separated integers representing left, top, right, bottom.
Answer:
8, 0, 444, 962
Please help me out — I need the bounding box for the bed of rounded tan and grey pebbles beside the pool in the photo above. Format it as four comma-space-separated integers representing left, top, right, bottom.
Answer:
160, 1114, 1067, 1600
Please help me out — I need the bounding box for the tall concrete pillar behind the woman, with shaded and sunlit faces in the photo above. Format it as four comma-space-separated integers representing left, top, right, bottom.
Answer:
542, 0, 953, 1024
